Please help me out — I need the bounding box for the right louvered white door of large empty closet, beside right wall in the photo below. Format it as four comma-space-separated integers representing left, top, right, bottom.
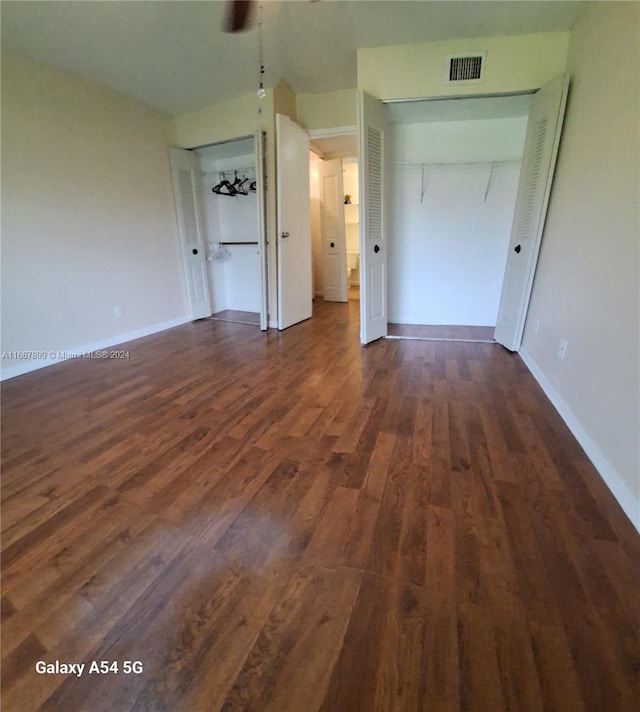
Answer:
494, 74, 569, 351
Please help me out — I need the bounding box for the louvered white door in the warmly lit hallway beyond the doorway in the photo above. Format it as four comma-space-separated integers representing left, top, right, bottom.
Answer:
320, 158, 349, 302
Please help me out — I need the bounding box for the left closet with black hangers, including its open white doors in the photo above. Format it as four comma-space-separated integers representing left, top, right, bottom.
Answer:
169, 132, 268, 331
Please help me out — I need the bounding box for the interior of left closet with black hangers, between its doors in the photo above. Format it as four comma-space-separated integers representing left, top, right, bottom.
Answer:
194, 136, 262, 326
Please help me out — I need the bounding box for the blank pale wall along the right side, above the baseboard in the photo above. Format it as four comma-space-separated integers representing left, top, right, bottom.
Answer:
522, 2, 640, 529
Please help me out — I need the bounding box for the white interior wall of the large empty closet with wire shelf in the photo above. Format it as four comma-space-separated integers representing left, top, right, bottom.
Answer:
388, 117, 527, 326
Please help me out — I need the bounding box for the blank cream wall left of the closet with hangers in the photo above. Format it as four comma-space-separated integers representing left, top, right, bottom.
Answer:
2, 56, 187, 377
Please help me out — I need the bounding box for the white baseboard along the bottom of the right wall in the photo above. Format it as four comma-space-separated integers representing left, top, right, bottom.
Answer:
519, 349, 640, 532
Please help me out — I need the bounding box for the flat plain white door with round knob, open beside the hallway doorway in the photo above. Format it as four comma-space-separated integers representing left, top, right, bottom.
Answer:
276, 114, 313, 329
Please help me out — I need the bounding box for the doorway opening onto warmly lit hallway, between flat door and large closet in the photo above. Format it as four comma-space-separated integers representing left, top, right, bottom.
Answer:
309, 127, 360, 308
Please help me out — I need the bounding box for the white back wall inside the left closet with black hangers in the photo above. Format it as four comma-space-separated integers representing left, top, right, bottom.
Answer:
201, 154, 262, 313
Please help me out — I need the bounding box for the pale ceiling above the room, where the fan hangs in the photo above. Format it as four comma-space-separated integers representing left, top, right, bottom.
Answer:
0, 0, 579, 114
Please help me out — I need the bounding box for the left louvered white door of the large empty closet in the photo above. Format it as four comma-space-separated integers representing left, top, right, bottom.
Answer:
358, 92, 388, 344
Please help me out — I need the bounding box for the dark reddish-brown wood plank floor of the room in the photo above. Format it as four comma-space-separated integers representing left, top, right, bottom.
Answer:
1, 301, 640, 712
